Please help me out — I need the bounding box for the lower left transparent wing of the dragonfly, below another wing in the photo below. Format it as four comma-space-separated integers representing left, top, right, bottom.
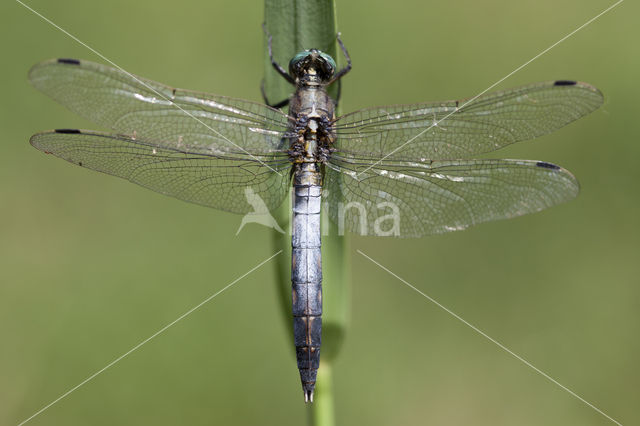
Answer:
30, 130, 291, 213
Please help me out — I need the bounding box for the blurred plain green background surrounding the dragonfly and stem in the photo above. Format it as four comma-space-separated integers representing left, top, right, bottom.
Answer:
0, 0, 640, 425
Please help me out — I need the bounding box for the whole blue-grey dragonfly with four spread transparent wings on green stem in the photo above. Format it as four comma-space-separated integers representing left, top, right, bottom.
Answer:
29, 36, 603, 402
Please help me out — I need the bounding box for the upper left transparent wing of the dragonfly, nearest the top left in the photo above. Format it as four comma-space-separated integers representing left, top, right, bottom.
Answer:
29, 59, 288, 158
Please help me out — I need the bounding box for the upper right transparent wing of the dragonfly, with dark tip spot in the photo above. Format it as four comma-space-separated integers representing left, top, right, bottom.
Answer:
335, 81, 603, 161
